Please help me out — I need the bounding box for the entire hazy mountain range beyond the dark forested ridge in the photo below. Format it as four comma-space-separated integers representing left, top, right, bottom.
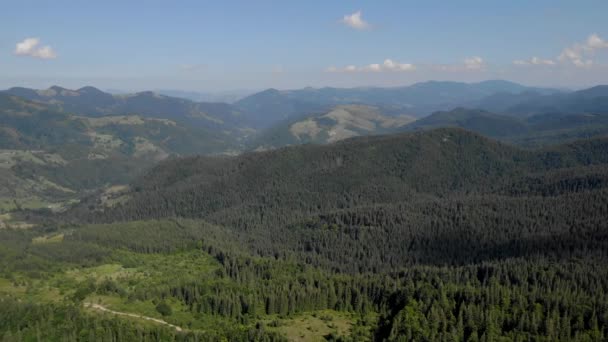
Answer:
0, 81, 608, 210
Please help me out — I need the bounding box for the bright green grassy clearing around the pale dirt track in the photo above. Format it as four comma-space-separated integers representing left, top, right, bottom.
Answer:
0, 233, 376, 341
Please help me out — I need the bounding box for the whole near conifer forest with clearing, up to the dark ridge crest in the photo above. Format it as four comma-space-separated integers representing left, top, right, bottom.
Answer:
0, 128, 608, 341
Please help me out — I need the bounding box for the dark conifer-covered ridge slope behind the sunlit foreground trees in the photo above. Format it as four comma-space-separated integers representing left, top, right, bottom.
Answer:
66, 129, 608, 271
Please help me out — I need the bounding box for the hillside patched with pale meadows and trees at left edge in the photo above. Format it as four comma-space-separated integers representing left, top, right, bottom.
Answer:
0, 94, 237, 211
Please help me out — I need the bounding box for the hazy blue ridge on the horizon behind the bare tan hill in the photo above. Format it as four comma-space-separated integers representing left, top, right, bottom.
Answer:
235, 80, 557, 128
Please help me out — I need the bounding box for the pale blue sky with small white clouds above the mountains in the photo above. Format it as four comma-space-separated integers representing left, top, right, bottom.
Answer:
0, 0, 608, 92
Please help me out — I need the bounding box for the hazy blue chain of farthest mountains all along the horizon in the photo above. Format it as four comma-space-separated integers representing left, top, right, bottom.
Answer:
4, 80, 560, 135
